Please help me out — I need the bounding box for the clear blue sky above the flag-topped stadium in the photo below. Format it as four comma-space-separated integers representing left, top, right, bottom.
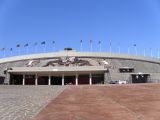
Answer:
0, 0, 160, 57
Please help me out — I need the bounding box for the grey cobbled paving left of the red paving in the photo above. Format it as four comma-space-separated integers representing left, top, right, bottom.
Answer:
0, 85, 65, 120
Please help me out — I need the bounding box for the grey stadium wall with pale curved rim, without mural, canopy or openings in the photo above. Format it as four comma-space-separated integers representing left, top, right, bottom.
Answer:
0, 51, 160, 83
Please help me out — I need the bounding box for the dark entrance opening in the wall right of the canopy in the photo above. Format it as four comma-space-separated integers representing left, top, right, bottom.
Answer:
132, 74, 149, 83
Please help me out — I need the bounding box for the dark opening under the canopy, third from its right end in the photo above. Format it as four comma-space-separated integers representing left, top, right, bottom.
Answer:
64, 76, 76, 85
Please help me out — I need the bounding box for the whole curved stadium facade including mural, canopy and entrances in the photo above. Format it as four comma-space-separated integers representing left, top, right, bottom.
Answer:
0, 50, 160, 85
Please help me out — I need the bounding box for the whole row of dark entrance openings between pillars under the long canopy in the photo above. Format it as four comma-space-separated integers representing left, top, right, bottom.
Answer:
10, 73, 104, 85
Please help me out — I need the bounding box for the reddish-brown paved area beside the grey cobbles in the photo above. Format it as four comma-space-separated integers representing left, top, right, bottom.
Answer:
34, 84, 160, 120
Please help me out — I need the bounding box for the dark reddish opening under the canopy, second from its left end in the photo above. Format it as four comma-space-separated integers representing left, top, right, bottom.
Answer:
25, 75, 35, 85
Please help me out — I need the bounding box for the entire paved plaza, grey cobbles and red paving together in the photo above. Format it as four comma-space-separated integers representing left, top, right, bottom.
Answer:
0, 84, 160, 120
